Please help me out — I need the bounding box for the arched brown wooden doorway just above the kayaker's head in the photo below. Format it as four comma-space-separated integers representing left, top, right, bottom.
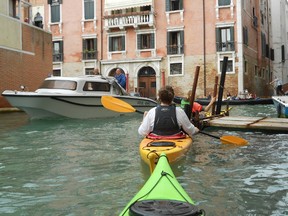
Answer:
138, 67, 156, 99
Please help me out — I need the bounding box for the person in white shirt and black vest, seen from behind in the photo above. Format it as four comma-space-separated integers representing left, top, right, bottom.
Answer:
138, 86, 199, 137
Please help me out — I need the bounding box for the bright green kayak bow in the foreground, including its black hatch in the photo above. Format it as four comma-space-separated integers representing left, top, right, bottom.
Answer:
120, 153, 205, 216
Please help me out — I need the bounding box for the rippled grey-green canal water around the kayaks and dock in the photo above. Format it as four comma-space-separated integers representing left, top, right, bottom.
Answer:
0, 105, 288, 216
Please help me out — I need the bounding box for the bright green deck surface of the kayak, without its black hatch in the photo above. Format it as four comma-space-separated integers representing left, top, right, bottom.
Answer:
120, 153, 201, 216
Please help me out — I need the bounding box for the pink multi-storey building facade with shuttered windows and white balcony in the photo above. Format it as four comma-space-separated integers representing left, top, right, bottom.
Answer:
44, 0, 273, 98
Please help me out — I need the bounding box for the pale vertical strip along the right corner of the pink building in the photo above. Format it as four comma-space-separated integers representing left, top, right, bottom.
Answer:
236, 0, 244, 94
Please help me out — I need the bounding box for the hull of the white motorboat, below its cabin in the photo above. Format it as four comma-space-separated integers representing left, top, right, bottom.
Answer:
2, 90, 157, 119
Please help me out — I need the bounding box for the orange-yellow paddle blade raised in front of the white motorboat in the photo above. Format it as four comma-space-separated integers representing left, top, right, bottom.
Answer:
101, 95, 136, 113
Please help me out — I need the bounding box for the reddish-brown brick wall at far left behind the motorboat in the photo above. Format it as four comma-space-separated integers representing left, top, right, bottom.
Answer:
0, 23, 52, 108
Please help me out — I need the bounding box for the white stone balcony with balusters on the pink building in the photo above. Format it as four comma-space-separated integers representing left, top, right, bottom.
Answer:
104, 11, 155, 31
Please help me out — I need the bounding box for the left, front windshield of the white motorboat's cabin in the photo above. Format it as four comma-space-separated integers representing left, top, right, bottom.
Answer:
39, 80, 77, 90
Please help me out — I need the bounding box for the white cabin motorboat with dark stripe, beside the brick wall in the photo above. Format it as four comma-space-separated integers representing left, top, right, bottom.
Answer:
2, 75, 157, 119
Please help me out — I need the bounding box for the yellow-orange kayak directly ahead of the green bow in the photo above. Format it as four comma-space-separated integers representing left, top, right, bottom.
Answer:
139, 135, 192, 172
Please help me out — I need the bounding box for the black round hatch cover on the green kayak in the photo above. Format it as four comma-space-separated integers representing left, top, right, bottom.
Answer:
129, 200, 203, 216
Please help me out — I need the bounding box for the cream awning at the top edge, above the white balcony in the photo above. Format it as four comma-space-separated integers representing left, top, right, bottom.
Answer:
105, 0, 153, 10
